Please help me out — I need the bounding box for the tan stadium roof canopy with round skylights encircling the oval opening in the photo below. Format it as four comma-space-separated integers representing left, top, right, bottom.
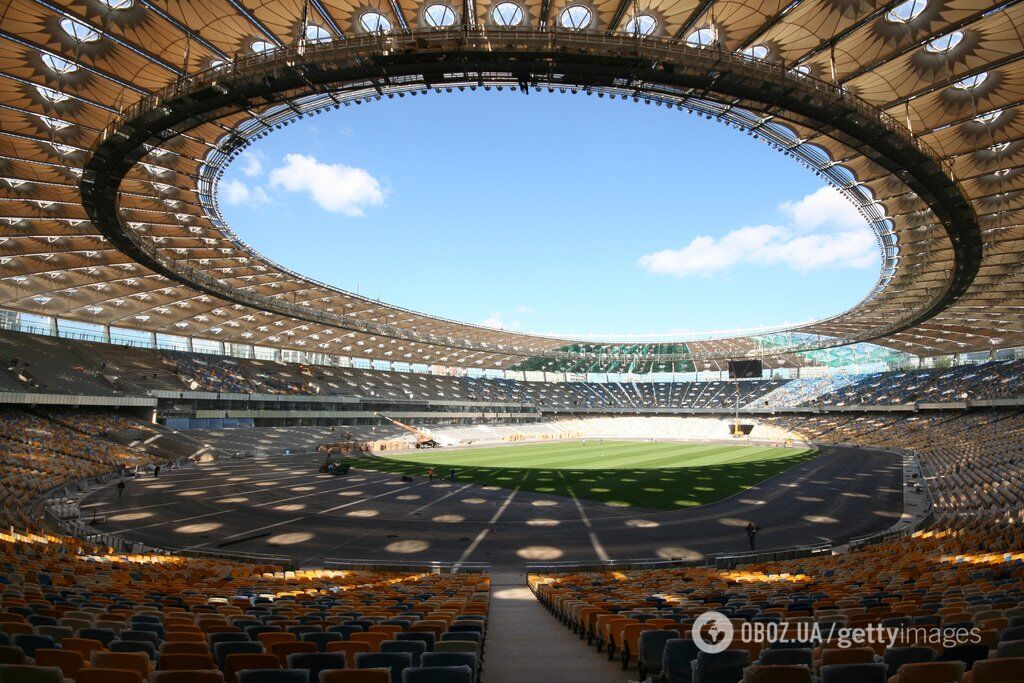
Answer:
0, 0, 1024, 369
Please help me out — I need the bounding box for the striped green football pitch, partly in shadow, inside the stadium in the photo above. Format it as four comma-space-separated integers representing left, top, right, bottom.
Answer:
346, 439, 817, 510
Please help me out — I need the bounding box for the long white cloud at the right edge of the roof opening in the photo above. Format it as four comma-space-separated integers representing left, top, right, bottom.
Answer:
638, 187, 879, 278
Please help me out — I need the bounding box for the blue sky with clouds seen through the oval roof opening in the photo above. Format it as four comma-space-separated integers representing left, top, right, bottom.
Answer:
220, 91, 879, 336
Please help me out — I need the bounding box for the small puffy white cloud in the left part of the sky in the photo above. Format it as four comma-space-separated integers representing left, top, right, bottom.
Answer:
270, 154, 385, 216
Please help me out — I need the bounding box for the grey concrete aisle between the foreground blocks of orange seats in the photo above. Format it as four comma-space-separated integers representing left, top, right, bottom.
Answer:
483, 572, 636, 683
